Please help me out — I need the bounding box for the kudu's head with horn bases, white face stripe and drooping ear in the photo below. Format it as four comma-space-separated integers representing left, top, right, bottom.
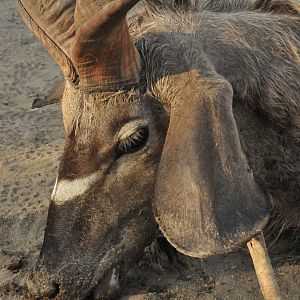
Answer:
19, 0, 268, 299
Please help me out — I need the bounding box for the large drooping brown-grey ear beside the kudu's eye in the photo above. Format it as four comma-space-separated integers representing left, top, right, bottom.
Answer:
154, 75, 270, 257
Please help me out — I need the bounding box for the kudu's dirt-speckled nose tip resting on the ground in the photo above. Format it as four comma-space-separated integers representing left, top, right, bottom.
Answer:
26, 273, 59, 299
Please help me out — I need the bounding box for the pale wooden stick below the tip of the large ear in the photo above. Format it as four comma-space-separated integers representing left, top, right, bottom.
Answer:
247, 233, 282, 300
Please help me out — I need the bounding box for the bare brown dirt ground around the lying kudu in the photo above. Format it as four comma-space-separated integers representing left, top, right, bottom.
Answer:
0, 0, 300, 300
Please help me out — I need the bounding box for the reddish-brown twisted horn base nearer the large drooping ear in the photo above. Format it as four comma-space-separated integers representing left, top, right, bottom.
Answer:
71, 0, 140, 91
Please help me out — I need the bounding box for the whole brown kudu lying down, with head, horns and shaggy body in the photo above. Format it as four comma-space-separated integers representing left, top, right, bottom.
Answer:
18, 0, 300, 299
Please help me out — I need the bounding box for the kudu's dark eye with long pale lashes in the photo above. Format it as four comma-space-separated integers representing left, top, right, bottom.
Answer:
119, 127, 149, 154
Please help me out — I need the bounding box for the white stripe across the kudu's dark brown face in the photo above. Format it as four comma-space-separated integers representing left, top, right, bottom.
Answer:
51, 173, 99, 205
